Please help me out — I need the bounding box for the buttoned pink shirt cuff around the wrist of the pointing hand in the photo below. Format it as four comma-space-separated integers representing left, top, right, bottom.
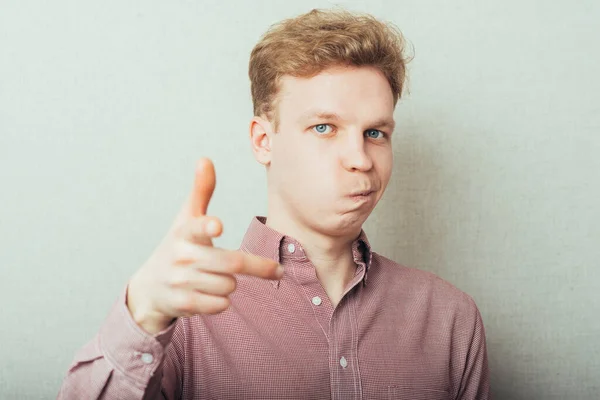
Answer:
99, 285, 177, 387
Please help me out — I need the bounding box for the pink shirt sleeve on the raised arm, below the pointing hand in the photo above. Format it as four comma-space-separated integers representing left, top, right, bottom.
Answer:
57, 287, 183, 400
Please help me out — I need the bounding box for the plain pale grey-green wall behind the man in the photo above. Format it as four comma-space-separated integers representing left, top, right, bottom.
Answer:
0, 0, 600, 400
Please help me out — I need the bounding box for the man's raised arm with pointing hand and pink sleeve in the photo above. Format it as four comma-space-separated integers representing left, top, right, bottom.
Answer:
58, 159, 283, 400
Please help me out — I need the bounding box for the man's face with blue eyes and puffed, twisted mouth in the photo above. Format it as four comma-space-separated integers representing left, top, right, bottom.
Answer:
268, 67, 394, 236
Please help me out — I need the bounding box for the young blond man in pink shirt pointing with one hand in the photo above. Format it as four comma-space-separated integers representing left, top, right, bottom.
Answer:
59, 10, 489, 400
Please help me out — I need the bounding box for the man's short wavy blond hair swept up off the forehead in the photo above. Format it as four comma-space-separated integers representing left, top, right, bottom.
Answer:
248, 9, 409, 129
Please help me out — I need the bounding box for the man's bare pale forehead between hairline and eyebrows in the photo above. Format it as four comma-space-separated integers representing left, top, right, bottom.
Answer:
277, 67, 394, 123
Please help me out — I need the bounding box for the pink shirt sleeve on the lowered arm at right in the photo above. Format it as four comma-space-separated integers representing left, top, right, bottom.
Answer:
456, 296, 491, 400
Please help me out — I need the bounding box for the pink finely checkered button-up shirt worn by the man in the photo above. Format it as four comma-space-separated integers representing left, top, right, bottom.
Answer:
58, 217, 490, 400
